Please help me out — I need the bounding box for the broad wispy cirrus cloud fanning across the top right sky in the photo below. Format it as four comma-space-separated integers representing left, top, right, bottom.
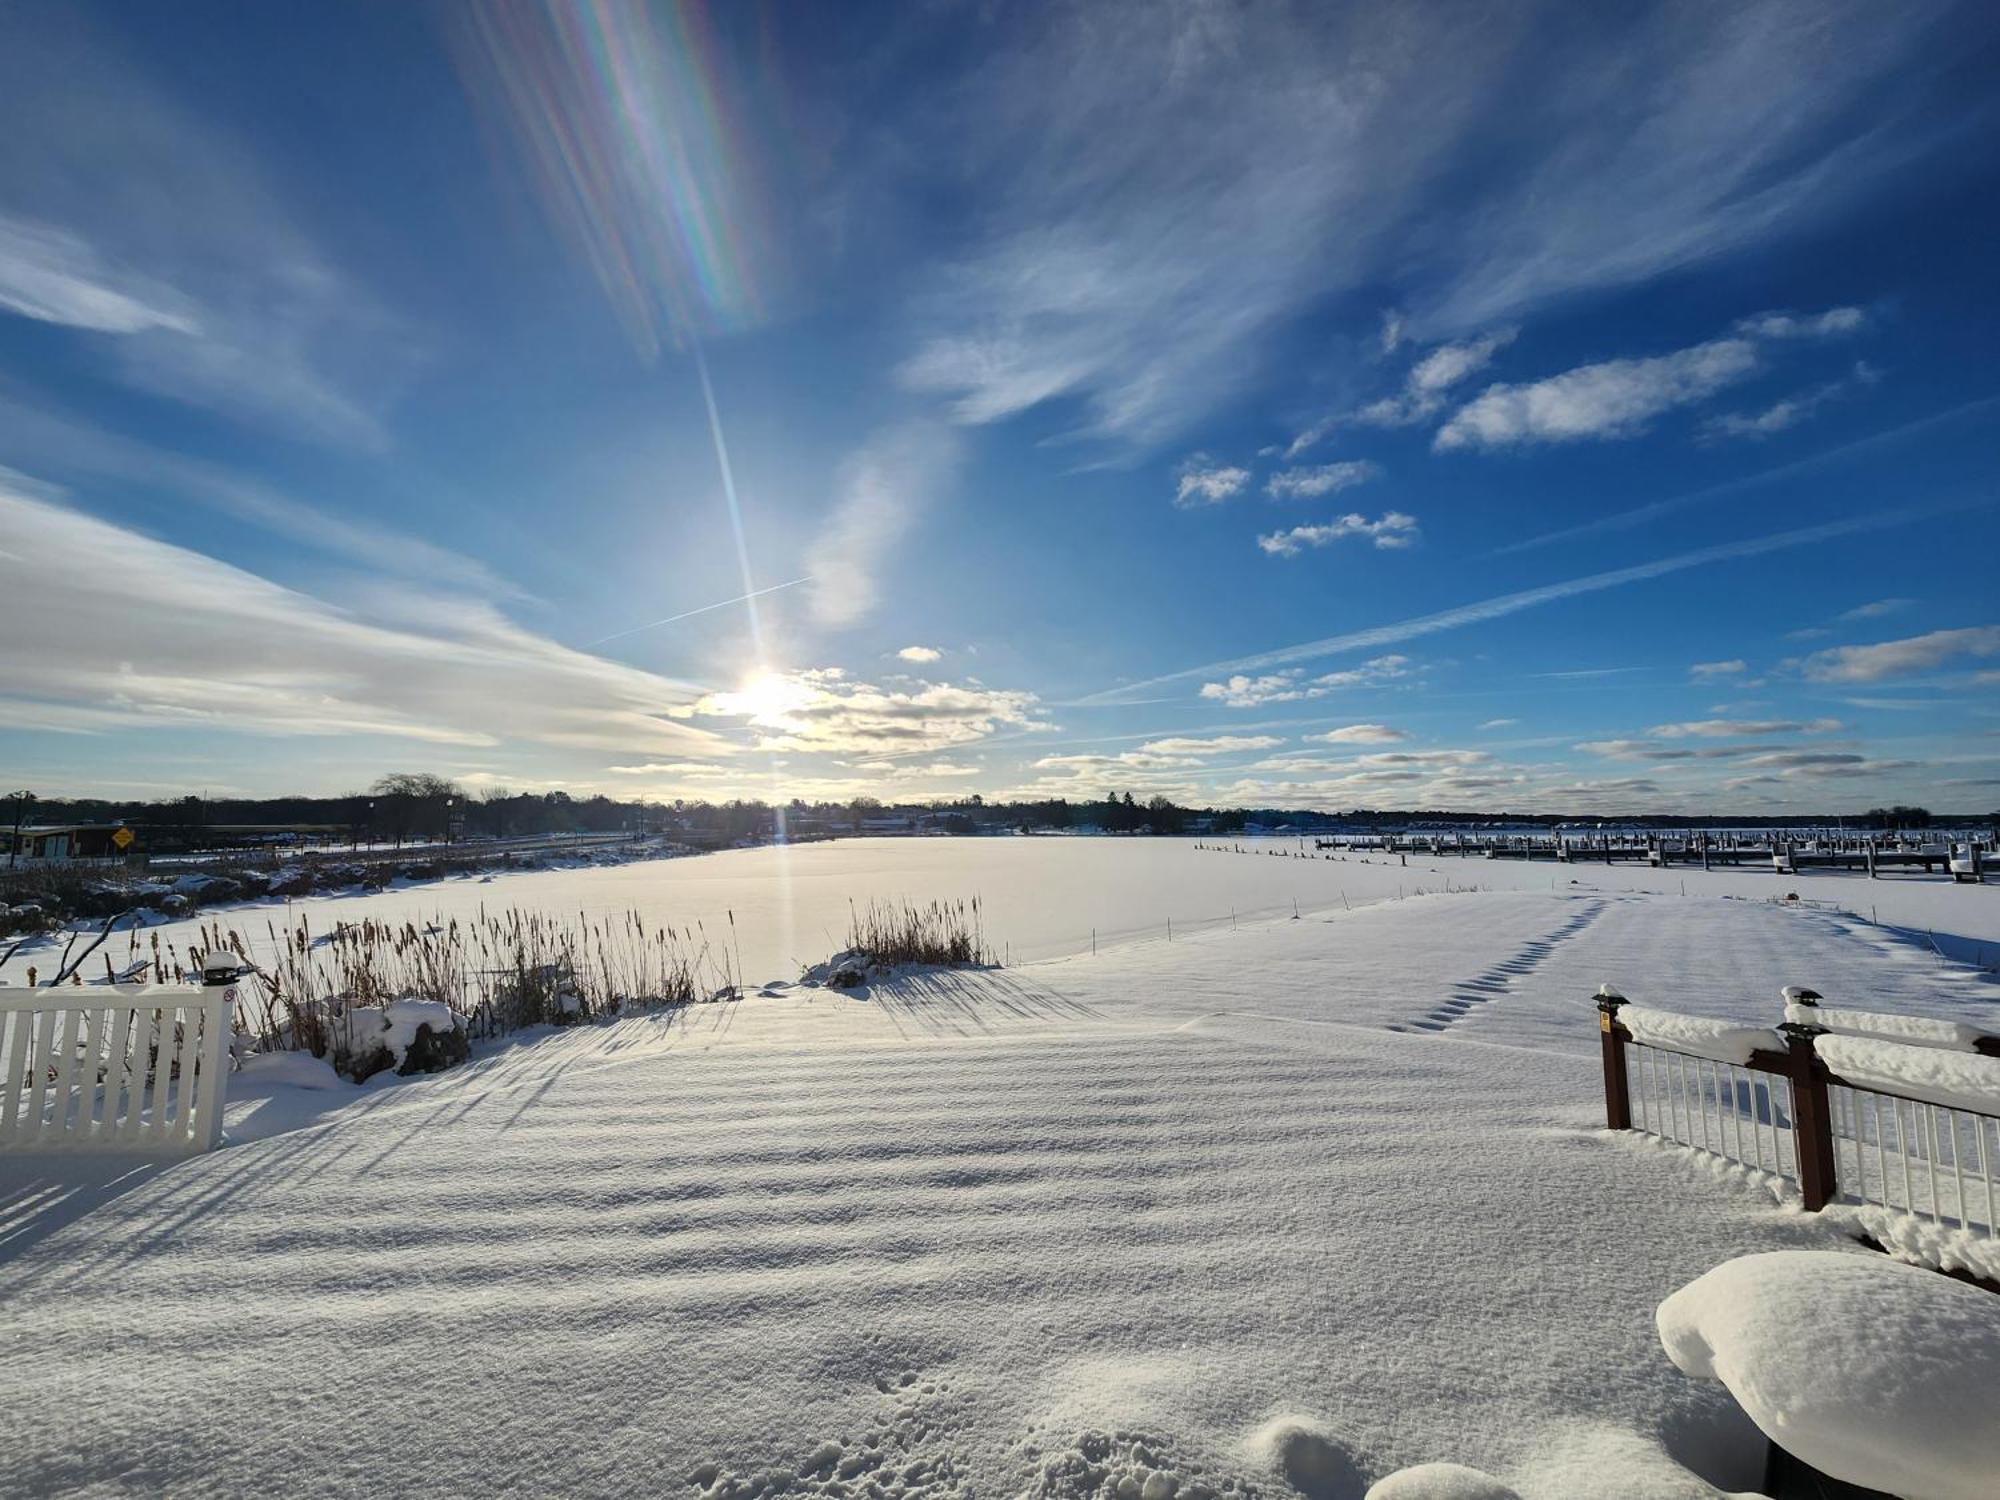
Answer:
894, 0, 1938, 456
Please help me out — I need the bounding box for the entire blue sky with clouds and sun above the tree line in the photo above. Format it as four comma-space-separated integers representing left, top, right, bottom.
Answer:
0, 0, 2000, 814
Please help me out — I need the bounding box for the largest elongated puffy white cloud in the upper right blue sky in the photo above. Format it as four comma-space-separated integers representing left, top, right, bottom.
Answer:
1434, 338, 1758, 450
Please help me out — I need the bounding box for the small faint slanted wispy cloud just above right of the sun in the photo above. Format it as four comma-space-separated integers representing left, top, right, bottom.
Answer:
810, 424, 958, 628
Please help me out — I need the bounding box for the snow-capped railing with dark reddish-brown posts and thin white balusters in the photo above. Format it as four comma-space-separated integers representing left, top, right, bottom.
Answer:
1598, 988, 2000, 1242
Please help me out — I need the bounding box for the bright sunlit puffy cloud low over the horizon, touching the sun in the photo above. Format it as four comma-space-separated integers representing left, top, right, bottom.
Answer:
670, 668, 1042, 756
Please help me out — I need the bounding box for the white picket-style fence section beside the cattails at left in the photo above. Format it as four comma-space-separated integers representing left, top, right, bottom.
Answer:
0, 958, 236, 1156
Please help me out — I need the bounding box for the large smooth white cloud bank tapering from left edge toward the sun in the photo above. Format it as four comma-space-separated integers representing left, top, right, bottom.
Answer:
0, 488, 732, 758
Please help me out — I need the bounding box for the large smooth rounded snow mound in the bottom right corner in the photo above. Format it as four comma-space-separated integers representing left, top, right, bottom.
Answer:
1658, 1250, 2000, 1500
